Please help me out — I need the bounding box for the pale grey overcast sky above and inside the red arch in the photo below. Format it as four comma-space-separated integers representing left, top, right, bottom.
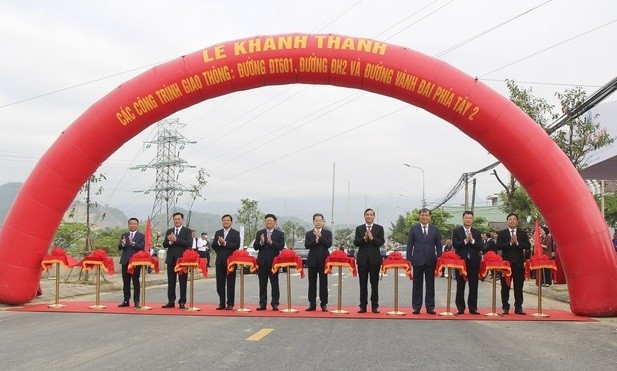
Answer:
0, 0, 617, 228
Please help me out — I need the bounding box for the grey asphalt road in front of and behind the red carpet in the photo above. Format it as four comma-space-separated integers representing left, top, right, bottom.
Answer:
0, 274, 617, 370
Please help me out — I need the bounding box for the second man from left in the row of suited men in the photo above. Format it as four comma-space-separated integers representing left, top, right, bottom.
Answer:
163, 212, 193, 309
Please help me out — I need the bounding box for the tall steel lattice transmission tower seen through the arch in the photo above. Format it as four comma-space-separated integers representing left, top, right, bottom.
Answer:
131, 118, 196, 228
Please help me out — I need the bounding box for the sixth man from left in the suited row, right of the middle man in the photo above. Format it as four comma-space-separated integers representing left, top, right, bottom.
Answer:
353, 209, 385, 313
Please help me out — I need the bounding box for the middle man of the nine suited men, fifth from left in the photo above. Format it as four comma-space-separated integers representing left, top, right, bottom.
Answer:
304, 213, 332, 312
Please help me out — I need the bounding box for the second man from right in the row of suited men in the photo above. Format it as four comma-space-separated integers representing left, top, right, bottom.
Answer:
452, 211, 484, 314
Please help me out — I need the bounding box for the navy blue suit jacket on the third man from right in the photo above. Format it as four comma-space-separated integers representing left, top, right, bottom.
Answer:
407, 223, 443, 267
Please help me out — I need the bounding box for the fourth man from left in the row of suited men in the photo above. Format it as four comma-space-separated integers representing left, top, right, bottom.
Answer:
253, 214, 285, 311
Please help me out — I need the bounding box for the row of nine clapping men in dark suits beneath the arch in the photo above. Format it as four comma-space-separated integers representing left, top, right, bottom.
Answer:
118, 208, 552, 315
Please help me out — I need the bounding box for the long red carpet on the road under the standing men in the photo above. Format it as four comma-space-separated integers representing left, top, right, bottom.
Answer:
9, 301, 595, 322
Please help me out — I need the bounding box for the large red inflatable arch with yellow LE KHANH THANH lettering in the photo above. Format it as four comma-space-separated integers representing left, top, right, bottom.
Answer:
0, 34, 617, 316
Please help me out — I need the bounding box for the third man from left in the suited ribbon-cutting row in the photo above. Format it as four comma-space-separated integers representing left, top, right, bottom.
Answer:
212, 214, 240, 310
